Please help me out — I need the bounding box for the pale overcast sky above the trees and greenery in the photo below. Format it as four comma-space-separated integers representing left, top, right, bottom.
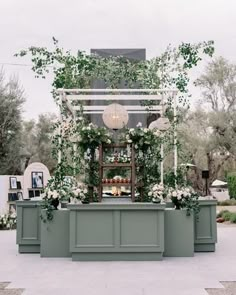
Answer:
0, 0, 236, 119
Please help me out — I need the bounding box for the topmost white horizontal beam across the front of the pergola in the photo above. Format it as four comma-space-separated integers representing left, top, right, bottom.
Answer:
56, 88, 178, 93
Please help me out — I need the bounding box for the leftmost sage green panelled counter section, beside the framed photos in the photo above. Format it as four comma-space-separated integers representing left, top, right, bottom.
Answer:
16, 201, 41, 253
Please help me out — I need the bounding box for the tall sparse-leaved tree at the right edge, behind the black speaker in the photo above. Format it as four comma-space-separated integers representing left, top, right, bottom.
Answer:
179, 57, 236, 192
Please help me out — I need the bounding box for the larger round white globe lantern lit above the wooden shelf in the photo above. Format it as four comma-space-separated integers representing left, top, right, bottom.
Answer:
102, 103, 129, 130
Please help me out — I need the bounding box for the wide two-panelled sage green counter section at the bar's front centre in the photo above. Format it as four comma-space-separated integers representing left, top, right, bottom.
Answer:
67, 203, 165, 261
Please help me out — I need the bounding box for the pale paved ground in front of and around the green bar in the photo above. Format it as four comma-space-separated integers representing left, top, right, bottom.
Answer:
0, 225, 236, 295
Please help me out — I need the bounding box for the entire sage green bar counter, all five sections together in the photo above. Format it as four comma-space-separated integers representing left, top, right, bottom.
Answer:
17, 200, 217, 261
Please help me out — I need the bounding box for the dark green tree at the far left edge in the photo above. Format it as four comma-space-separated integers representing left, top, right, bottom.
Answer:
0, 71, 25, 174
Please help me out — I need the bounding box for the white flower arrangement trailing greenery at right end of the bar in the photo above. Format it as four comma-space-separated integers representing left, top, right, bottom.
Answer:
167, 187, 200, 216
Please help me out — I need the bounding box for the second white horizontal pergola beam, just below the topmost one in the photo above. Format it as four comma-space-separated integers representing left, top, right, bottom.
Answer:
66, 94, 162, 101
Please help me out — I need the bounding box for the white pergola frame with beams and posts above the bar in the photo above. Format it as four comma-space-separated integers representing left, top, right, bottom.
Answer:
57, 89, 178, 183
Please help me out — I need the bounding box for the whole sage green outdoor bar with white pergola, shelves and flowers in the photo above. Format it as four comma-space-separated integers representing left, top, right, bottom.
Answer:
17, 89, 217, 261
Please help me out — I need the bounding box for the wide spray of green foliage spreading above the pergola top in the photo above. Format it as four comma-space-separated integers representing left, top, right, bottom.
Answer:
15, 38, 214, 109
